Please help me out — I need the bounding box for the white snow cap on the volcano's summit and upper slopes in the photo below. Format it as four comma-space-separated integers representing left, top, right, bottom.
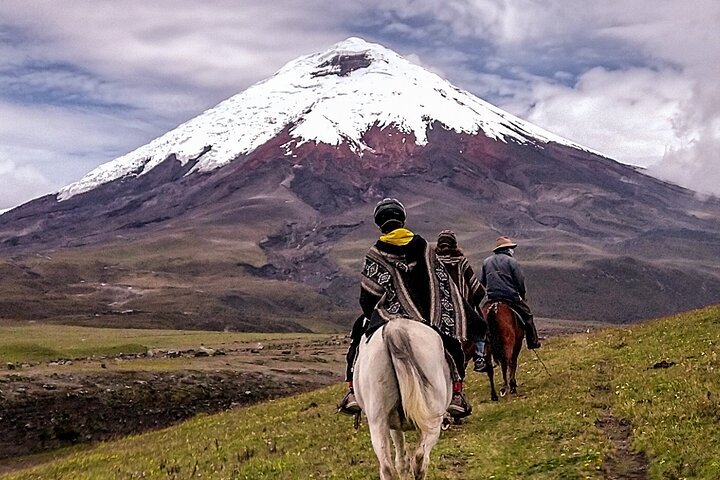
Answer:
58, 38, 588, 200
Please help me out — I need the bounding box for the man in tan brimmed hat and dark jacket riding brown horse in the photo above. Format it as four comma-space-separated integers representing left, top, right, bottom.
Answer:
480, 237, 540, 349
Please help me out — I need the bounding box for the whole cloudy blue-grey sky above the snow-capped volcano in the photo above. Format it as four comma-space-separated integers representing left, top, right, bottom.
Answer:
0, 0, 720, 209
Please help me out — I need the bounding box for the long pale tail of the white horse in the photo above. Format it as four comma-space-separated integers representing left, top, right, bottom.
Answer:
383, 322, 436, 430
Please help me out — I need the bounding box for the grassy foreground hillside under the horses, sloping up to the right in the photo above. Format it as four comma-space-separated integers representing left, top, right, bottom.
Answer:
2, 307, 720, 479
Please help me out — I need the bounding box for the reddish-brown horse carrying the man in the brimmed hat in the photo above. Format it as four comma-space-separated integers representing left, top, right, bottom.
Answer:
483, 301, 525, 400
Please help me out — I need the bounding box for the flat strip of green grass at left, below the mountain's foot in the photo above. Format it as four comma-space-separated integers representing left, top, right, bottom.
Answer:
0, 322, 320, 363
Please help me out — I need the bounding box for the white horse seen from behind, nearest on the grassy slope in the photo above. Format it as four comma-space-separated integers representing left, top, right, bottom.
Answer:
353, 317, 452, 480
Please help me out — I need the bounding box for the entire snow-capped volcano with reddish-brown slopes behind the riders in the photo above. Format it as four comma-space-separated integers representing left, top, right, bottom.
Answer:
0, 39, 720, 330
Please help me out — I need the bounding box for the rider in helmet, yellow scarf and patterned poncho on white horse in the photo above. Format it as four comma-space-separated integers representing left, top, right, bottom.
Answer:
338, 198, 472, 417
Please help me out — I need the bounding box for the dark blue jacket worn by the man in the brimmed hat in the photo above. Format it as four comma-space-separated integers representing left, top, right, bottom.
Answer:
480, 250, 525, 301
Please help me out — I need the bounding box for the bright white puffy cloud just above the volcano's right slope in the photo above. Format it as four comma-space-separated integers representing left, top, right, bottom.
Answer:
503, 68, 690, 166
